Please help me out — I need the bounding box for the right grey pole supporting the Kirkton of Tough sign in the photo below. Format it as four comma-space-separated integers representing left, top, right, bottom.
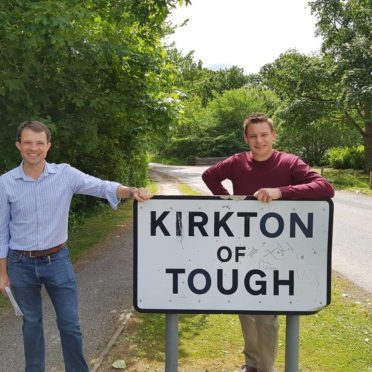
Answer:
285, 315, 300, 372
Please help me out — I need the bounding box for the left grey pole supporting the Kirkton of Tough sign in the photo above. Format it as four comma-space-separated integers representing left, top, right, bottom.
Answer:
165, 314, 178, 372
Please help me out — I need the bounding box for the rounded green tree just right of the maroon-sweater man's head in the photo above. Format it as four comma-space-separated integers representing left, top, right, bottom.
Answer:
261, 50, 360, 164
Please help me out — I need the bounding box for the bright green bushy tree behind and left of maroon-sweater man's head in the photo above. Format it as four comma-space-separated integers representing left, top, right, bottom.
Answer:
163, 88, 278, 160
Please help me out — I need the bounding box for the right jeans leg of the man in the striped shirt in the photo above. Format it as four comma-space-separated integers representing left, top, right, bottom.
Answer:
42, 248, 89, 372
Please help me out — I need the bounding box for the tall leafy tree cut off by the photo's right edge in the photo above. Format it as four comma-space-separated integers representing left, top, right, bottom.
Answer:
309, 0, 372, 171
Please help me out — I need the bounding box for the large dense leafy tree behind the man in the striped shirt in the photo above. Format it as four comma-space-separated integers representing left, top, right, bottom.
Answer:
0, 0, 188, 184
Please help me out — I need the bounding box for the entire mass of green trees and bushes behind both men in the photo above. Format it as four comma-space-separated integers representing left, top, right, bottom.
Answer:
0, 0, 372, 189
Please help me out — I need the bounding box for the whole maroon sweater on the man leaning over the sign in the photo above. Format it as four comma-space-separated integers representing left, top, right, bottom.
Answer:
202, 151, 334, 199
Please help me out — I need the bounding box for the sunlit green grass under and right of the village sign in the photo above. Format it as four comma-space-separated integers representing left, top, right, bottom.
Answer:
100, 277, 372, 372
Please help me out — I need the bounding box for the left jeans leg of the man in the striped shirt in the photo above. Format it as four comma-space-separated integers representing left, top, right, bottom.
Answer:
8, 250, 45, 372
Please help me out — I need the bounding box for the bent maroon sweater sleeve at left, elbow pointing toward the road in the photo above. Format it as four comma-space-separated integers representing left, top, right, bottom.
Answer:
202, 158, 232, 195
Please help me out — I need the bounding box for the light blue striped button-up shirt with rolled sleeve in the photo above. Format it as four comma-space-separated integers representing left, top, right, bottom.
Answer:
0, 162, 120, 258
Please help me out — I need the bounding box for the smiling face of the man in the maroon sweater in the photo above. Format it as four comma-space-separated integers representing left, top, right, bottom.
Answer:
244, 122, 276, 161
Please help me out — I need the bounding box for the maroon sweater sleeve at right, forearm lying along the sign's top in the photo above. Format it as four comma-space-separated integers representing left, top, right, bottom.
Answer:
279, 158, 335, 199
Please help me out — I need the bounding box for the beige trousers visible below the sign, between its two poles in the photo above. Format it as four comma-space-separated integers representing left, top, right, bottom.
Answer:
239, 314, 279, 372
